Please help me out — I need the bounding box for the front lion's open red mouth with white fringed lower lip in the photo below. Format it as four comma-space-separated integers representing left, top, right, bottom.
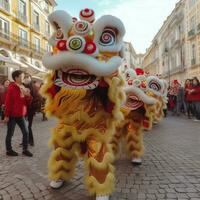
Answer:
54, 68, 99, 90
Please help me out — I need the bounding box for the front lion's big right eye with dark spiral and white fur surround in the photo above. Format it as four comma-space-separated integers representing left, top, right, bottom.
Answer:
93, 15, 125, 52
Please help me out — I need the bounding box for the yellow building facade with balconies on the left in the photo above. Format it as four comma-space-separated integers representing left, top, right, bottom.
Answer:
0, 0, 56, 80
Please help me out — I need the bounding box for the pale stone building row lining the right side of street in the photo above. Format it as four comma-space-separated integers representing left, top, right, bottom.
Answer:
143, 0, 200, 84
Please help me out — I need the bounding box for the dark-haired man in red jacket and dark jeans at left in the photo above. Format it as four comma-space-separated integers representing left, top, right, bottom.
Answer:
4, 70, 33, 157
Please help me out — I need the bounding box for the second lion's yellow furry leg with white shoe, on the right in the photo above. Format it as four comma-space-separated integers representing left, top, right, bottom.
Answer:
126, 123, 144, 164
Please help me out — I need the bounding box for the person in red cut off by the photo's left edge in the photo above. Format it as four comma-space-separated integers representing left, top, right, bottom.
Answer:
0, 79, 10, 120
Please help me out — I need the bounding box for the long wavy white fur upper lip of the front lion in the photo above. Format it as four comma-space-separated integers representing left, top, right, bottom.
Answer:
43, 52, 122, 77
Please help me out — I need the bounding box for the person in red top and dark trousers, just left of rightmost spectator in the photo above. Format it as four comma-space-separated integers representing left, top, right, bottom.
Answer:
185, 79, 193, 119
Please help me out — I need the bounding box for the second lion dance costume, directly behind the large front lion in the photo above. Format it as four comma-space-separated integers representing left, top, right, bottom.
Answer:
111, 68, 156, 165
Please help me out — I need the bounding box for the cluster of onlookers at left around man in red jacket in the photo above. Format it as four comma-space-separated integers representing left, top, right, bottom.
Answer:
0, 70, 47, 157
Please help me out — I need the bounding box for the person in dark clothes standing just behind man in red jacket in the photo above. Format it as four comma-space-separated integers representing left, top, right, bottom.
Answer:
24, 73, 42, 146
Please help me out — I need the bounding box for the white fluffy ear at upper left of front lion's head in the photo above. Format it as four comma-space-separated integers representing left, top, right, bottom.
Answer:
48, 10, 73, 46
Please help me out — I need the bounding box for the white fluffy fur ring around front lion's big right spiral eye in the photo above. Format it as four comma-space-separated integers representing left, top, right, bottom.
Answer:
93, 15, 125, 52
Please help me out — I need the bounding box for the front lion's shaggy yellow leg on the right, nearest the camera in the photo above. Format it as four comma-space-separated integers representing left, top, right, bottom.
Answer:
85, 137, 115, 199
